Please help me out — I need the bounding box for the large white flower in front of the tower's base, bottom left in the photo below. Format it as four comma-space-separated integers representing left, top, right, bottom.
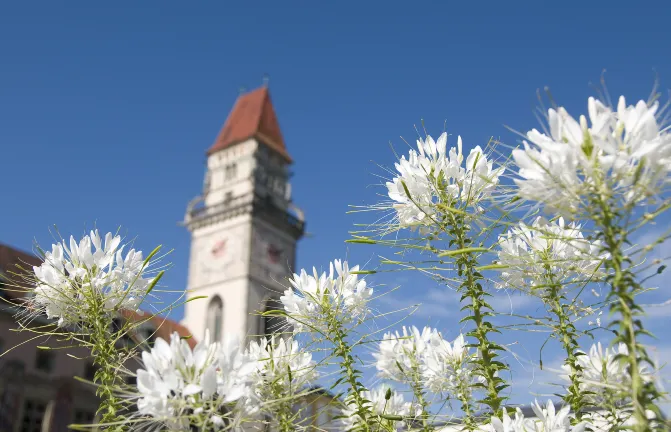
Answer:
137, 333, 254, 430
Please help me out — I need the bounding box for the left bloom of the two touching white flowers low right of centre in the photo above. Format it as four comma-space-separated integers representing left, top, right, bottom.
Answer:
373, 326, 440, 383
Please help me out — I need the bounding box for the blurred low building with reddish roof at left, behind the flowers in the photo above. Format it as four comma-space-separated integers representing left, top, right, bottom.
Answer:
0, 244, 195, 432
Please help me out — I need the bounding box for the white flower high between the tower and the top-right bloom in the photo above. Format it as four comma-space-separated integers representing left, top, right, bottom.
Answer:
386, 133, 504, 226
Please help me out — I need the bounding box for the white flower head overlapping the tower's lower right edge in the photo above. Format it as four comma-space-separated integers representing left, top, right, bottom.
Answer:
280, 260, 373, 333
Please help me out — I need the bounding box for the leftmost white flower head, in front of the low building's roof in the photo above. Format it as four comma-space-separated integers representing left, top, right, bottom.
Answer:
31, 230, 152, 325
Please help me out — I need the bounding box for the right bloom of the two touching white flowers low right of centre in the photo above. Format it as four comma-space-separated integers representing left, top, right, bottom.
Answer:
422, 334, 483, 398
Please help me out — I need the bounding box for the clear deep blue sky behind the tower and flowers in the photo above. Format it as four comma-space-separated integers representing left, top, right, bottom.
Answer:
0, 1, 671, 410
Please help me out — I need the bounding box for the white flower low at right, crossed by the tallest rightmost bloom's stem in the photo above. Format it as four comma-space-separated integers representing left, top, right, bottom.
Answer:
562, 342, 652, 406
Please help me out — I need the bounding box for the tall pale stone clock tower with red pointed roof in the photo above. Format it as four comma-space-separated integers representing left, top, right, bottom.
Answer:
182, 86, 304, 340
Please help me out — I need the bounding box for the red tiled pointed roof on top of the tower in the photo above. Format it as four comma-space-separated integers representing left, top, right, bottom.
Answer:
207, 84, 291, 163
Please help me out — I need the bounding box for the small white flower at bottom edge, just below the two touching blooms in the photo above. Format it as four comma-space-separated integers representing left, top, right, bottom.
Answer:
342, 385, 421, 430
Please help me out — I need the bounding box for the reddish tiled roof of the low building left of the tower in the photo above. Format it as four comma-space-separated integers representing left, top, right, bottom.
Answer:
0, 243, 197, 348
